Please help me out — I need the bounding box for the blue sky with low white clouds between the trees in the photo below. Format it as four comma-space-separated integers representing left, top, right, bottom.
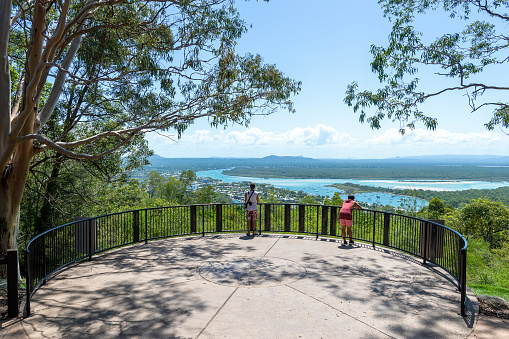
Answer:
147, 0, 509, 159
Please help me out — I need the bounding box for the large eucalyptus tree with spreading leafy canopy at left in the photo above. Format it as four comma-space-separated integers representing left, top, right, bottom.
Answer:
0, 0, 300, 252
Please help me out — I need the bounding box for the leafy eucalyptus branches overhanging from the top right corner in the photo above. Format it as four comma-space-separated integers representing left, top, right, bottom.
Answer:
345, 0, 509, 133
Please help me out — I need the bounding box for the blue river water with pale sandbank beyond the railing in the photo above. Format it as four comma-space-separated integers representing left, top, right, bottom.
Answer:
196, 169, 509, 207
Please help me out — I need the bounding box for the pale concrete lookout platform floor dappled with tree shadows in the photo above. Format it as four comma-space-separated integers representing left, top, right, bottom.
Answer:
18, 233, 477, 338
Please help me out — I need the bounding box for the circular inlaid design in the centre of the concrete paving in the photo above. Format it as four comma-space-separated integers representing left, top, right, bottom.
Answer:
200, 257, 306, 287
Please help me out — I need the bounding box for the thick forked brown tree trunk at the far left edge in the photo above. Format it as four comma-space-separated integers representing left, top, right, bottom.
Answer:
0, 1, 39, 255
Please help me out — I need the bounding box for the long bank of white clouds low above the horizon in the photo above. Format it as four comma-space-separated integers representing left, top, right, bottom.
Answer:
147, 124, 509, 158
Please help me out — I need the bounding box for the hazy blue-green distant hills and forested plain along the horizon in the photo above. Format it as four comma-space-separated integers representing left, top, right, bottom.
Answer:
141, 155, 509, 182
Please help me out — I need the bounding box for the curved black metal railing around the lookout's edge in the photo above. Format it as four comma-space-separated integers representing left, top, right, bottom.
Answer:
25, 203, 467, 316
